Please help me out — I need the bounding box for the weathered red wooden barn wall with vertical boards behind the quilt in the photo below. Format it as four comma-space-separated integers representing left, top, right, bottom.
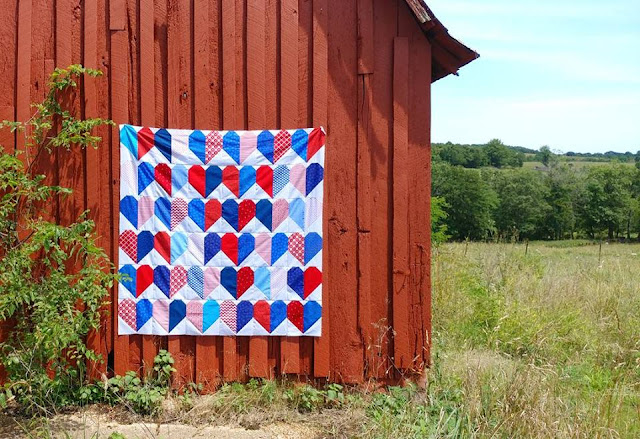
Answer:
0, 0, 431, 386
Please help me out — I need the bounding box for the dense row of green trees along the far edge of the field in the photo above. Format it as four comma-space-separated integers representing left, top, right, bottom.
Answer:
432, 160, 640, 240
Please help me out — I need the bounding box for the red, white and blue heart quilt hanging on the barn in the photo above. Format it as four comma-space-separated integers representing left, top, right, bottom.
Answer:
118, 125, 325, 337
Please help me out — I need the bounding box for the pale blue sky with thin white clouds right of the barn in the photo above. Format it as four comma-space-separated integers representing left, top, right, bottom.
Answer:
427, 0, 640, 153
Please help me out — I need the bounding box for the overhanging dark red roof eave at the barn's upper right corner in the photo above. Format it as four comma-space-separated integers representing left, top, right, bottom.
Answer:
405, 0, 480, 82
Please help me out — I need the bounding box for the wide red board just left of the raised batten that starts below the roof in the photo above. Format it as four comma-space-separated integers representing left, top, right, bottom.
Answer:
367, 0, 398, 379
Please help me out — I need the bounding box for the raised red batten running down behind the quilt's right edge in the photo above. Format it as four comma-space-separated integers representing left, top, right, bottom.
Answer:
312, 0, 331, 378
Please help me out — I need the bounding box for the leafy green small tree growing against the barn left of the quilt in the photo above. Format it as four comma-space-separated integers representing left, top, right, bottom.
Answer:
0, 65, 115, 411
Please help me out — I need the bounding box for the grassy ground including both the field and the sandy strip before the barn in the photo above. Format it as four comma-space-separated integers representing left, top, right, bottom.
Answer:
6, 241, 640, 439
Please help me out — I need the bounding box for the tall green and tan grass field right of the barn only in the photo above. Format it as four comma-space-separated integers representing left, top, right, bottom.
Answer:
422, 243, 640, 438
